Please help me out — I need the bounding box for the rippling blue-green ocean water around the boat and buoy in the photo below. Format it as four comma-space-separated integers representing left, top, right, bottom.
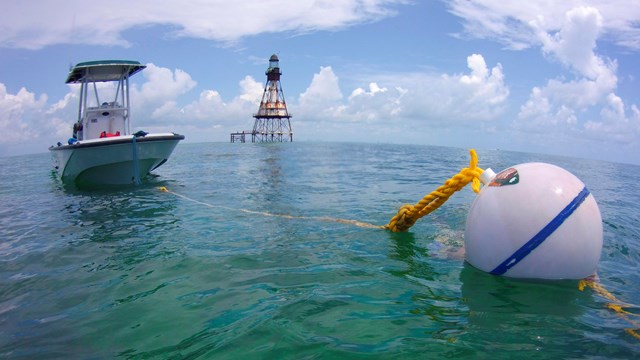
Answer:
0, 142, 640, 359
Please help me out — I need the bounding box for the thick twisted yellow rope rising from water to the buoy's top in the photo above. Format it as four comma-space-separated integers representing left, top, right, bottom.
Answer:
384, 149, 484, 232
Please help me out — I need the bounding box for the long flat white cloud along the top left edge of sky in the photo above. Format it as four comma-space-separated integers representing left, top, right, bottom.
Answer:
0, 0, 406, 49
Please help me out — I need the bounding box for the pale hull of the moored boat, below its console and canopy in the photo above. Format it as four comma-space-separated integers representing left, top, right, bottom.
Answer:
49, 133, 184, 187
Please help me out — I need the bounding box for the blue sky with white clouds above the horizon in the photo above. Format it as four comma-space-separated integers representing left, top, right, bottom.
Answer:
0, 0, 640, 164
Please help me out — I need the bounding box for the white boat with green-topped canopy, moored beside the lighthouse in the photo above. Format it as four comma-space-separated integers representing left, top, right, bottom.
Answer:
49, 60, 184, 187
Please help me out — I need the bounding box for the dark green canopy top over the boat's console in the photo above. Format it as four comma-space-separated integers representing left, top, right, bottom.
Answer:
66, 60, 146, 84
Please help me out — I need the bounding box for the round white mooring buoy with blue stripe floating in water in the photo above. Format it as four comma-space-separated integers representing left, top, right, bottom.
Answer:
464, 163, 603, 279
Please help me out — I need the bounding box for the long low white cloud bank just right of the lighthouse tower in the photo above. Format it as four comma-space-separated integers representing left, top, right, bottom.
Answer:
296, 54, 509, 127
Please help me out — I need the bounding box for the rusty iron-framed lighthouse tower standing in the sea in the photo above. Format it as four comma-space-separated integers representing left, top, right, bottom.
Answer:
251, 54, 293, 142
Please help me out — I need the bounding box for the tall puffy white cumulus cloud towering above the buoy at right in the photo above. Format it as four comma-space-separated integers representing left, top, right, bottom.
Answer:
514, 7, 638, 141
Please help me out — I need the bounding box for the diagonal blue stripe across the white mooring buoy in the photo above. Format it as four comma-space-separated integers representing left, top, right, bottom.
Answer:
491, 187, 589, 275
